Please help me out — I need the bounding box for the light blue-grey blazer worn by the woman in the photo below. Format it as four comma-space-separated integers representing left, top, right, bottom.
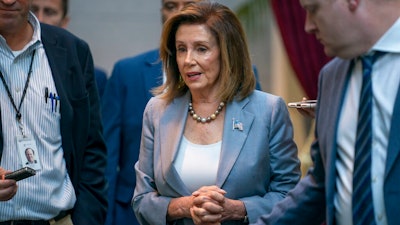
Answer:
132, 91, 301, 225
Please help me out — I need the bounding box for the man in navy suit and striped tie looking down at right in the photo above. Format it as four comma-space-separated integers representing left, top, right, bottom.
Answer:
256, 0, 400, 225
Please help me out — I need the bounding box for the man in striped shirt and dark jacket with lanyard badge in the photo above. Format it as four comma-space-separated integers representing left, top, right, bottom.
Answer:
0, 4, 107, 225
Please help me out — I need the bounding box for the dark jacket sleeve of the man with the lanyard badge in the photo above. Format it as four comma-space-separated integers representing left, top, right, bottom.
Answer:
72, 39, 107, 225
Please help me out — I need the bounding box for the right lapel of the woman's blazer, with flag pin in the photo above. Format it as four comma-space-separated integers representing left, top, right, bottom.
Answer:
216, 98, 254, 187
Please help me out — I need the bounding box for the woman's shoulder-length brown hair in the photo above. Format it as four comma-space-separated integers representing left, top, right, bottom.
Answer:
153, 1, 256, 102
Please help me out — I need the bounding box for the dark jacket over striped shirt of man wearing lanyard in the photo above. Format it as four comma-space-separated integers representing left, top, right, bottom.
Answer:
0, 24, 107, 225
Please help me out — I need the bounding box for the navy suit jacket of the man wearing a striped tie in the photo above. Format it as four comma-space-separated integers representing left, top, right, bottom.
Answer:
257, 59, 400, 225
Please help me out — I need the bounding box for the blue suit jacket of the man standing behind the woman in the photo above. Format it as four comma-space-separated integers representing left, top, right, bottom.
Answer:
102, 49, 163, 224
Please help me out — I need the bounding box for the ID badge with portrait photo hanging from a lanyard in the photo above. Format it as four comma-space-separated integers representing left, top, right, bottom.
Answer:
17, 135, 42, 170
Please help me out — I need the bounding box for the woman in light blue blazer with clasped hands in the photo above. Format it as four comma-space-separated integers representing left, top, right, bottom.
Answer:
132, 2, 300, 225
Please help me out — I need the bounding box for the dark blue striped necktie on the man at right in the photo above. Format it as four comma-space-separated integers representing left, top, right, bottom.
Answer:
352, 52, 383, 225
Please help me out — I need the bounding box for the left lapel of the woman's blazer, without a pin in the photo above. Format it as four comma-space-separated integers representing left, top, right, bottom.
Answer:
159, 92, 191, 196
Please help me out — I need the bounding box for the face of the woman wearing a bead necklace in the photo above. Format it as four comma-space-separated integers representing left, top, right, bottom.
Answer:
175, 24, 221, 94
